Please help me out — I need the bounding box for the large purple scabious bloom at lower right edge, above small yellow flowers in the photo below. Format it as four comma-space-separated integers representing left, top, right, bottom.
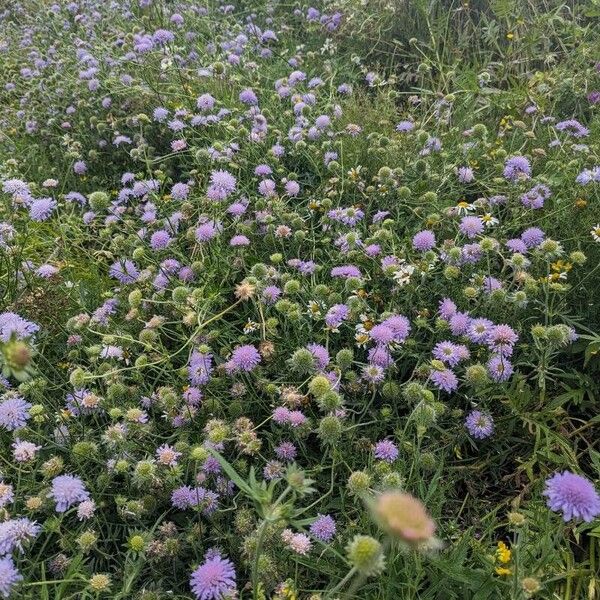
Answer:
542, 471, 600, 523
